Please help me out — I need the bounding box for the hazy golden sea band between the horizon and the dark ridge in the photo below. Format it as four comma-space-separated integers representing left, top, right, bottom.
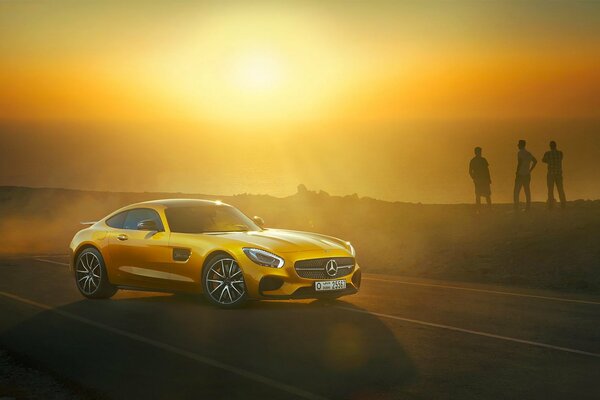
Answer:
0, 119, 600, 203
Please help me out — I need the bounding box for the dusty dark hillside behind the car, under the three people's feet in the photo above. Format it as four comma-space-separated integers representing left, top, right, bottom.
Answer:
0, 185, 600, 292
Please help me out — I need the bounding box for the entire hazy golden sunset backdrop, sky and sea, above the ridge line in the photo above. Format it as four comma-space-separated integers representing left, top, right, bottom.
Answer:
0, 0, 600, 202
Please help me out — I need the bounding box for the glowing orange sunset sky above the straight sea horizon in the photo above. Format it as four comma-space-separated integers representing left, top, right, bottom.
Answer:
0, 1, 600, 125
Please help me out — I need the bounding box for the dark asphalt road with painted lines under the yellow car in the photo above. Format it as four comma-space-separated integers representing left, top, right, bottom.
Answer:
0, 257, 600, 399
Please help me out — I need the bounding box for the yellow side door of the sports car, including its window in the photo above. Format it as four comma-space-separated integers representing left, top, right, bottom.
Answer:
107, 208, 172, 289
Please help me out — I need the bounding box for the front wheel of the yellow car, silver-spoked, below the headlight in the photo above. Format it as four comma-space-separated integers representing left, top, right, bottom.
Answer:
202, 254, 248, 308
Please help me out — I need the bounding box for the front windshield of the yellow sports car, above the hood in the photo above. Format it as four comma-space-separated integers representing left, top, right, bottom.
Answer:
165, 204, 260, 233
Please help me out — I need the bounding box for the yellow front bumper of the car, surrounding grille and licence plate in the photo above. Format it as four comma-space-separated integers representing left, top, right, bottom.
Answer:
238, 250, 362, 299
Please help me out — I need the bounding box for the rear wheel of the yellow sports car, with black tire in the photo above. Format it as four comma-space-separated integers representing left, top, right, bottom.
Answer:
74, 247, 118, 299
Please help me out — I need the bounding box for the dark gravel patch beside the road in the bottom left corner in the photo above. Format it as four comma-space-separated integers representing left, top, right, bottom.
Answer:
0, 349, 84, 400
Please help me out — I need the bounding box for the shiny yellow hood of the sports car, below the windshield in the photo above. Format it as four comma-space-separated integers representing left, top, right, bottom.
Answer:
211, 229, 347, 253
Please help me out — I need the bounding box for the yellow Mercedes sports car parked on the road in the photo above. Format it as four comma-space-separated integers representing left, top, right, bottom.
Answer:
70, 199, 361, 308
